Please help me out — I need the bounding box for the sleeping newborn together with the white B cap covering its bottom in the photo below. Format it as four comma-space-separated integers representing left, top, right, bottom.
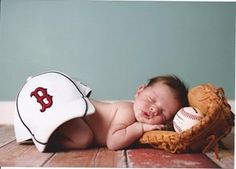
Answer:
14, 72, 188, 152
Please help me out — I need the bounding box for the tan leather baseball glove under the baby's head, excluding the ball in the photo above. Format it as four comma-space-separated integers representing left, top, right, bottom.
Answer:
139, 83, 234, 153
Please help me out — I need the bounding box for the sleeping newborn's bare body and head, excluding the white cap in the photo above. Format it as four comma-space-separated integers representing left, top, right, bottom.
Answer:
47, 76, 188, 150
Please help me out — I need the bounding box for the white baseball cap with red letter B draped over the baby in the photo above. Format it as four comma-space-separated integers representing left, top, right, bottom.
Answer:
14, 71, 95, 152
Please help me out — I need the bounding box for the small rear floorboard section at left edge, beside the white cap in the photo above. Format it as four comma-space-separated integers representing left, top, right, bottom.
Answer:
0, 125, 15, 147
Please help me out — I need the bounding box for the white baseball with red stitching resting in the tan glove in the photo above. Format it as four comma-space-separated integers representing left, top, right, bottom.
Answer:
173, 107, 203, 132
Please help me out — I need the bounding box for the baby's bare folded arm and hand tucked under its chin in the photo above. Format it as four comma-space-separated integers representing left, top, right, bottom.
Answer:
107, 122, 162, 150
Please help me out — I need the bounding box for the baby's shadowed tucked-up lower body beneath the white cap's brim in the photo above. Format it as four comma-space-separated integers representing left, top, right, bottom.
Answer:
46, 118, 94, 149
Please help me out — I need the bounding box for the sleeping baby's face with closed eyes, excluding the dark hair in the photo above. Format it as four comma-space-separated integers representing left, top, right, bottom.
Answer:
134, 82, 181, 124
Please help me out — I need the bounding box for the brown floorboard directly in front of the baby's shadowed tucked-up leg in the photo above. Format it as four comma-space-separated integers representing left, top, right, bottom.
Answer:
44, 148, 99, 167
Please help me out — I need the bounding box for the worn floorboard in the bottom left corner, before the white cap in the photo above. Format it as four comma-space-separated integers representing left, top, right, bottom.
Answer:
0, 141, 53, 167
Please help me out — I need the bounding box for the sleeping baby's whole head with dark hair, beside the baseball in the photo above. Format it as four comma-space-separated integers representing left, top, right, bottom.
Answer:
134, 75, 188, 124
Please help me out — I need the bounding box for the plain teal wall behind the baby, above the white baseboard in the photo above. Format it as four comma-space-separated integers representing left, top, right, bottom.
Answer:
0, 0, 236, 100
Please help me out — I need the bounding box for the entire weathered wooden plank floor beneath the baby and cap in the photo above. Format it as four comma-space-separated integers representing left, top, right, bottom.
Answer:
0, 126, 234, 169
